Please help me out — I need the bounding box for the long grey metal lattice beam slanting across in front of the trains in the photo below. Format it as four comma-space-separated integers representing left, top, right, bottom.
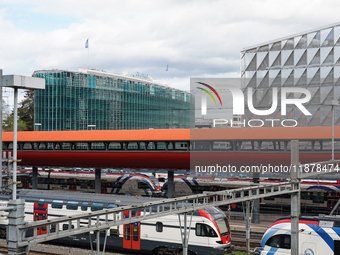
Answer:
18, 182, 300, 247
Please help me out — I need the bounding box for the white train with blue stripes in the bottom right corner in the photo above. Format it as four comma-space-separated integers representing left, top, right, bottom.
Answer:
254, 216, 340, 255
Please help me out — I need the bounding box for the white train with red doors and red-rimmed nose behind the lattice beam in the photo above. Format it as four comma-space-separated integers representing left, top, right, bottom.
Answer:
0, 194, 234, 255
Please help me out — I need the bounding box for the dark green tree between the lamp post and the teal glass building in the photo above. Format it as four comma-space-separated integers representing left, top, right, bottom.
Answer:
18, 90, 34, 131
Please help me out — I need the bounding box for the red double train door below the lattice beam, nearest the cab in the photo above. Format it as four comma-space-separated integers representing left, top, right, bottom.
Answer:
123, 212, 140, 250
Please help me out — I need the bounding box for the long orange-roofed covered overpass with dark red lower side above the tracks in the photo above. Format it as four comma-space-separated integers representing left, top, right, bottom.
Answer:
3, 126, 340, 197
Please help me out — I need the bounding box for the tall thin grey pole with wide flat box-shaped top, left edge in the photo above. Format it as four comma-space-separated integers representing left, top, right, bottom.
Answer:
0, 69, 45, 200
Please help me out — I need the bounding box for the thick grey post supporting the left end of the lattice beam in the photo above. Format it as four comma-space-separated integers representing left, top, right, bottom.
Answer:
7, 199, 28, 254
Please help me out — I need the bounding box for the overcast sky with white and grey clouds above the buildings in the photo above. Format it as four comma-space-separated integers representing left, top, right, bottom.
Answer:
0, 0, 340, 104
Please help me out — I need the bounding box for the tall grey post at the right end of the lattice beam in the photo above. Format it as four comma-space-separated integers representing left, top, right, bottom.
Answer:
290, 140, 300, 255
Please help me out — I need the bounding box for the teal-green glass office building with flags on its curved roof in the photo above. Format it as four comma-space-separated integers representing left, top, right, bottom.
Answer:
33, 69, 194, 131
